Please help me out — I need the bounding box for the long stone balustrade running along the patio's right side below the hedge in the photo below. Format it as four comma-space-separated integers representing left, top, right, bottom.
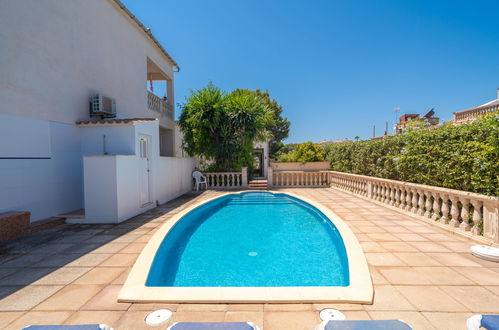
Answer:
329, 171, 499, 242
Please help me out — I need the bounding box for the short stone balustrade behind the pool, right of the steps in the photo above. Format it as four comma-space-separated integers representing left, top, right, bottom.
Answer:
269, 171, 329, 187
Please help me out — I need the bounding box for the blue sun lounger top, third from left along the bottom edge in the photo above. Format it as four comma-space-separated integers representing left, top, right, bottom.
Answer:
316, 320, 412, 330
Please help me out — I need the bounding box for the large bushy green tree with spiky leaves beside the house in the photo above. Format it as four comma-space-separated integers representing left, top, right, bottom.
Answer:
179, 83, 274, 171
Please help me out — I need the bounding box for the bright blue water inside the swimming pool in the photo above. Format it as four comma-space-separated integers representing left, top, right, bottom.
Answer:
146, 192, 349, 287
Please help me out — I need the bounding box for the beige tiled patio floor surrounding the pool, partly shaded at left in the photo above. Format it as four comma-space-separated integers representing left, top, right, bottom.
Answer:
0, 188, 499, 330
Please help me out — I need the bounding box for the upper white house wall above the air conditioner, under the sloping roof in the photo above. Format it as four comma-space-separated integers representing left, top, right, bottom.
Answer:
0, 0, 175, 128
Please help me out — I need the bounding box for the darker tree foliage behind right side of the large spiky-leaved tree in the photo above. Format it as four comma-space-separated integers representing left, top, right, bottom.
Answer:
235, 89, 291, 158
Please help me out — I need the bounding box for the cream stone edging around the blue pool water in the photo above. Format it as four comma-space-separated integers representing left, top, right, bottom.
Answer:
118, 190, 374, 304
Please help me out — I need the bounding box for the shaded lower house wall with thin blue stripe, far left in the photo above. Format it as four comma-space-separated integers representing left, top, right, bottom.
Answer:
0, 114, 83, 222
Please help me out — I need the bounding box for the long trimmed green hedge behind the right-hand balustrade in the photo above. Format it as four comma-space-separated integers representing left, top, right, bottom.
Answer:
324, 112, 499, 196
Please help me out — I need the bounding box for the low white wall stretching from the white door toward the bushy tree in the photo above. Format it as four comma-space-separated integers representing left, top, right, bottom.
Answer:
154, 157, 195, 204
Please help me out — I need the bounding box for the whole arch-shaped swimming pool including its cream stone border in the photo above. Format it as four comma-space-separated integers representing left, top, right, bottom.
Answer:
118, 191, 374, 303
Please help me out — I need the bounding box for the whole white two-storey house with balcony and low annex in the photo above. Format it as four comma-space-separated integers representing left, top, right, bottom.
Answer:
0, 0, 194, 222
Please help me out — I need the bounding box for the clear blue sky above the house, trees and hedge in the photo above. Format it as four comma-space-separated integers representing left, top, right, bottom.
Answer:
122, 0, 499, 143
